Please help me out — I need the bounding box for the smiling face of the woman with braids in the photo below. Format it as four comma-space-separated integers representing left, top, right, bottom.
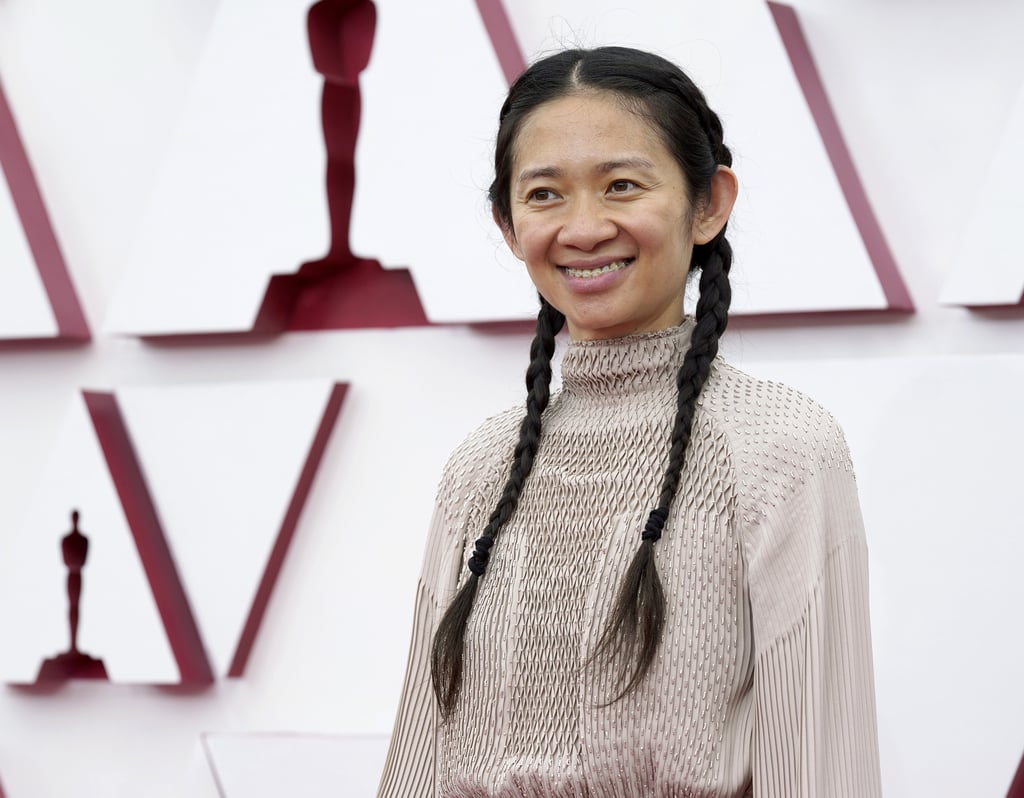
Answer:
504, 92, 708, 340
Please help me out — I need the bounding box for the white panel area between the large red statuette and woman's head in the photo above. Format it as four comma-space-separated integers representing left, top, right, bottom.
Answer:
351, 0, 537, 322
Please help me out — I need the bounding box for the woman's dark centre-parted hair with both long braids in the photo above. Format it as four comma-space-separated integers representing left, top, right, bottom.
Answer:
431, 47, 732, 717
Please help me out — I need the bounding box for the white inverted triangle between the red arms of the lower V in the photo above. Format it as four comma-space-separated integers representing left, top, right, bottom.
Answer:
119, 380, 332, 677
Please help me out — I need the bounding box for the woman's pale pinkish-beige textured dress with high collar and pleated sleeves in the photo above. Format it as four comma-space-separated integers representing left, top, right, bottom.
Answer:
379, 324, 881, 798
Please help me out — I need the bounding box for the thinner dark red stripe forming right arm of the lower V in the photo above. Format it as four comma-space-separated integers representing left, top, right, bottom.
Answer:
227, 383, 348, 676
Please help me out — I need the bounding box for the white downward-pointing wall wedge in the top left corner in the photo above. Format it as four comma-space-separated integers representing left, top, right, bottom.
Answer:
0, 0, 218, 321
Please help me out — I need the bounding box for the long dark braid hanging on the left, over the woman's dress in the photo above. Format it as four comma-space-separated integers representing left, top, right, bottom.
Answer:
430, 298, 565, 718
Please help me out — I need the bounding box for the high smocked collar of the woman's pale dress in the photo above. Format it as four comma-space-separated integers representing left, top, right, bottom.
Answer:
562, 318, 693, 397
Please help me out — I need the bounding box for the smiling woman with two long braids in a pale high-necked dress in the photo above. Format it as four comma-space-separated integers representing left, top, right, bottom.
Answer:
380, 48, 880, 798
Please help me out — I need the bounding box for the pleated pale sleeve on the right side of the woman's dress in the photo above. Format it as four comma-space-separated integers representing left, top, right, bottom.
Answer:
745, 417, 881, 798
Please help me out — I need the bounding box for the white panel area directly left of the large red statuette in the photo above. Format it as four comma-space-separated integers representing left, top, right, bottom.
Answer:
106, 0, 330, 334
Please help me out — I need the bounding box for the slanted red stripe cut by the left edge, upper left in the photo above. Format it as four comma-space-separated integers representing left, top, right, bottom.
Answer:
0, 73, 91, 341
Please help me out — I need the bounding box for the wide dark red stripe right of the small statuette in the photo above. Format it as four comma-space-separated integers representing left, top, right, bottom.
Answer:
82, 391, 213, 684
